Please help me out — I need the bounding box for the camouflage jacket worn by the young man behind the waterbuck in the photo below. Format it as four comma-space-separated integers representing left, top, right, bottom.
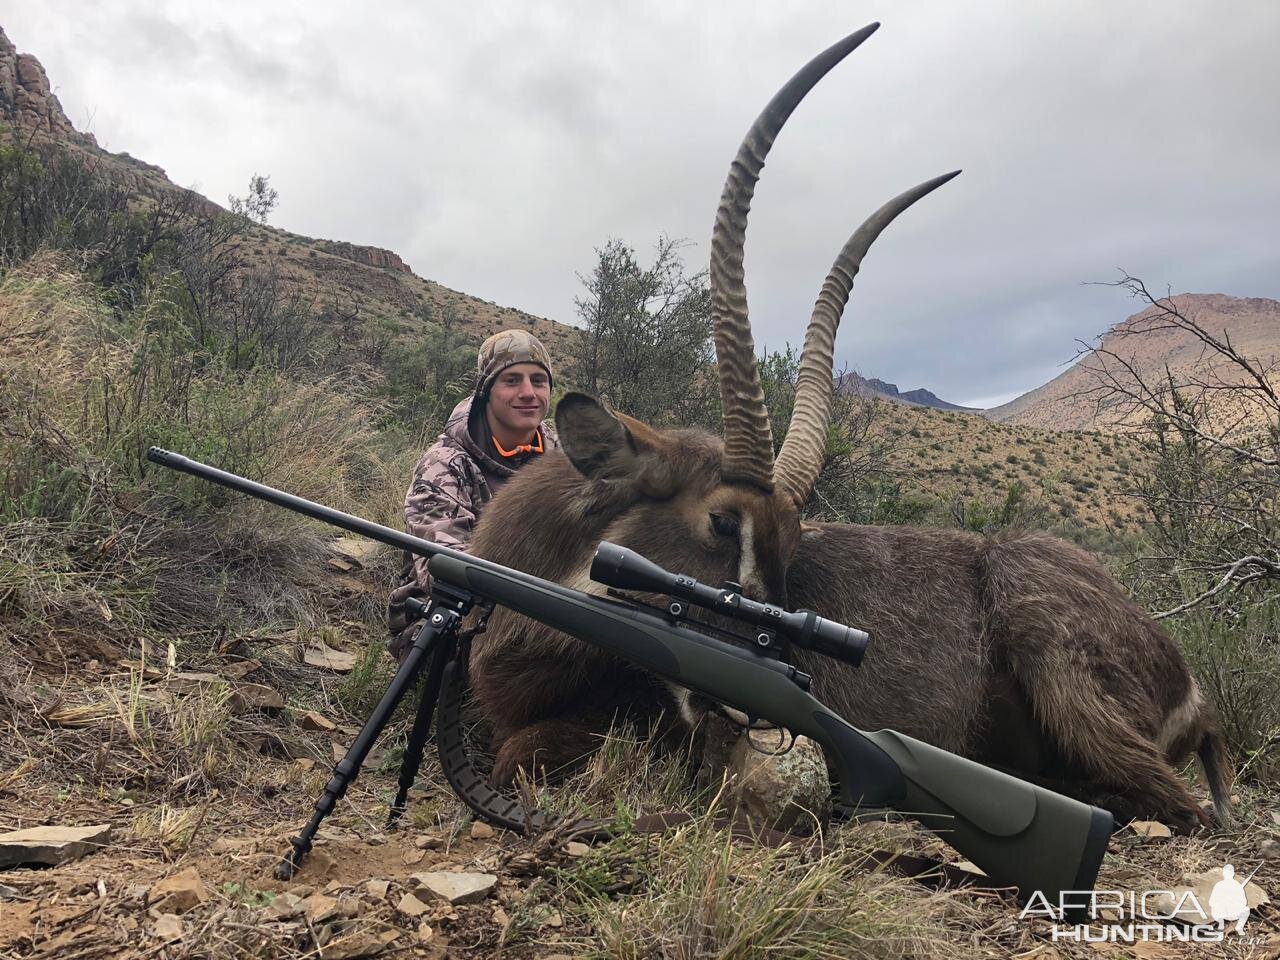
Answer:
388, 397, 559, 655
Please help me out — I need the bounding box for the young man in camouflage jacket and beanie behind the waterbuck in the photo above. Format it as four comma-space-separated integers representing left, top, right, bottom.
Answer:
388, 330, 559, 658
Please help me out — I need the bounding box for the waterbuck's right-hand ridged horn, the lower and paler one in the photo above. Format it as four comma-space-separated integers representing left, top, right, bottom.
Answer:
773, 170, 960, 507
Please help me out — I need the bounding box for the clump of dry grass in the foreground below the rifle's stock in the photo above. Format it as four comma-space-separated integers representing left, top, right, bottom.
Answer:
554, 810, 968, 960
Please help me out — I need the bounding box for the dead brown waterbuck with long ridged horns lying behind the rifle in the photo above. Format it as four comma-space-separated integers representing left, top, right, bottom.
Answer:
471, 24, 1230, 829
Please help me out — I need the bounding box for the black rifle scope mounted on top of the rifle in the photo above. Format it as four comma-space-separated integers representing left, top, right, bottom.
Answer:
591, 540, 870, 667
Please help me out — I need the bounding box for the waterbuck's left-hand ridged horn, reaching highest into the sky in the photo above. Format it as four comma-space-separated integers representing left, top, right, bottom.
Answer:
710, 23, 879, 492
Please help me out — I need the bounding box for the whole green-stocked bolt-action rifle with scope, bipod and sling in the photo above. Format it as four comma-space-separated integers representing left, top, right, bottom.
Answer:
147, 447, 1112, 902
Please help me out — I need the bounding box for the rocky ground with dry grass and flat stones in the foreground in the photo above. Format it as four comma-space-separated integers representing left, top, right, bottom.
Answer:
0, 542, 1280, 960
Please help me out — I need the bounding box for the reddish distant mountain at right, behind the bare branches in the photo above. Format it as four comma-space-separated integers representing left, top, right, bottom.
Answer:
984, 293, 1280, 430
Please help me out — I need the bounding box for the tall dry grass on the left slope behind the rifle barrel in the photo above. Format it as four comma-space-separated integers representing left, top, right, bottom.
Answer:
0, 257, 412, 660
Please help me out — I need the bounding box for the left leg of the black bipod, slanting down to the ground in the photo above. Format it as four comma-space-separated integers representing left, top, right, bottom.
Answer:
275, 603, 461, 881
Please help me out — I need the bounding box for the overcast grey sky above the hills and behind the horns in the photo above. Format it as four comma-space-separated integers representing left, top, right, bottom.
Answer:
10, 0, 1280, 406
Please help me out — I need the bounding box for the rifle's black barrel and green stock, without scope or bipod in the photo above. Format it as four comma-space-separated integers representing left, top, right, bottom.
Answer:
147, 447, 1112, 902
